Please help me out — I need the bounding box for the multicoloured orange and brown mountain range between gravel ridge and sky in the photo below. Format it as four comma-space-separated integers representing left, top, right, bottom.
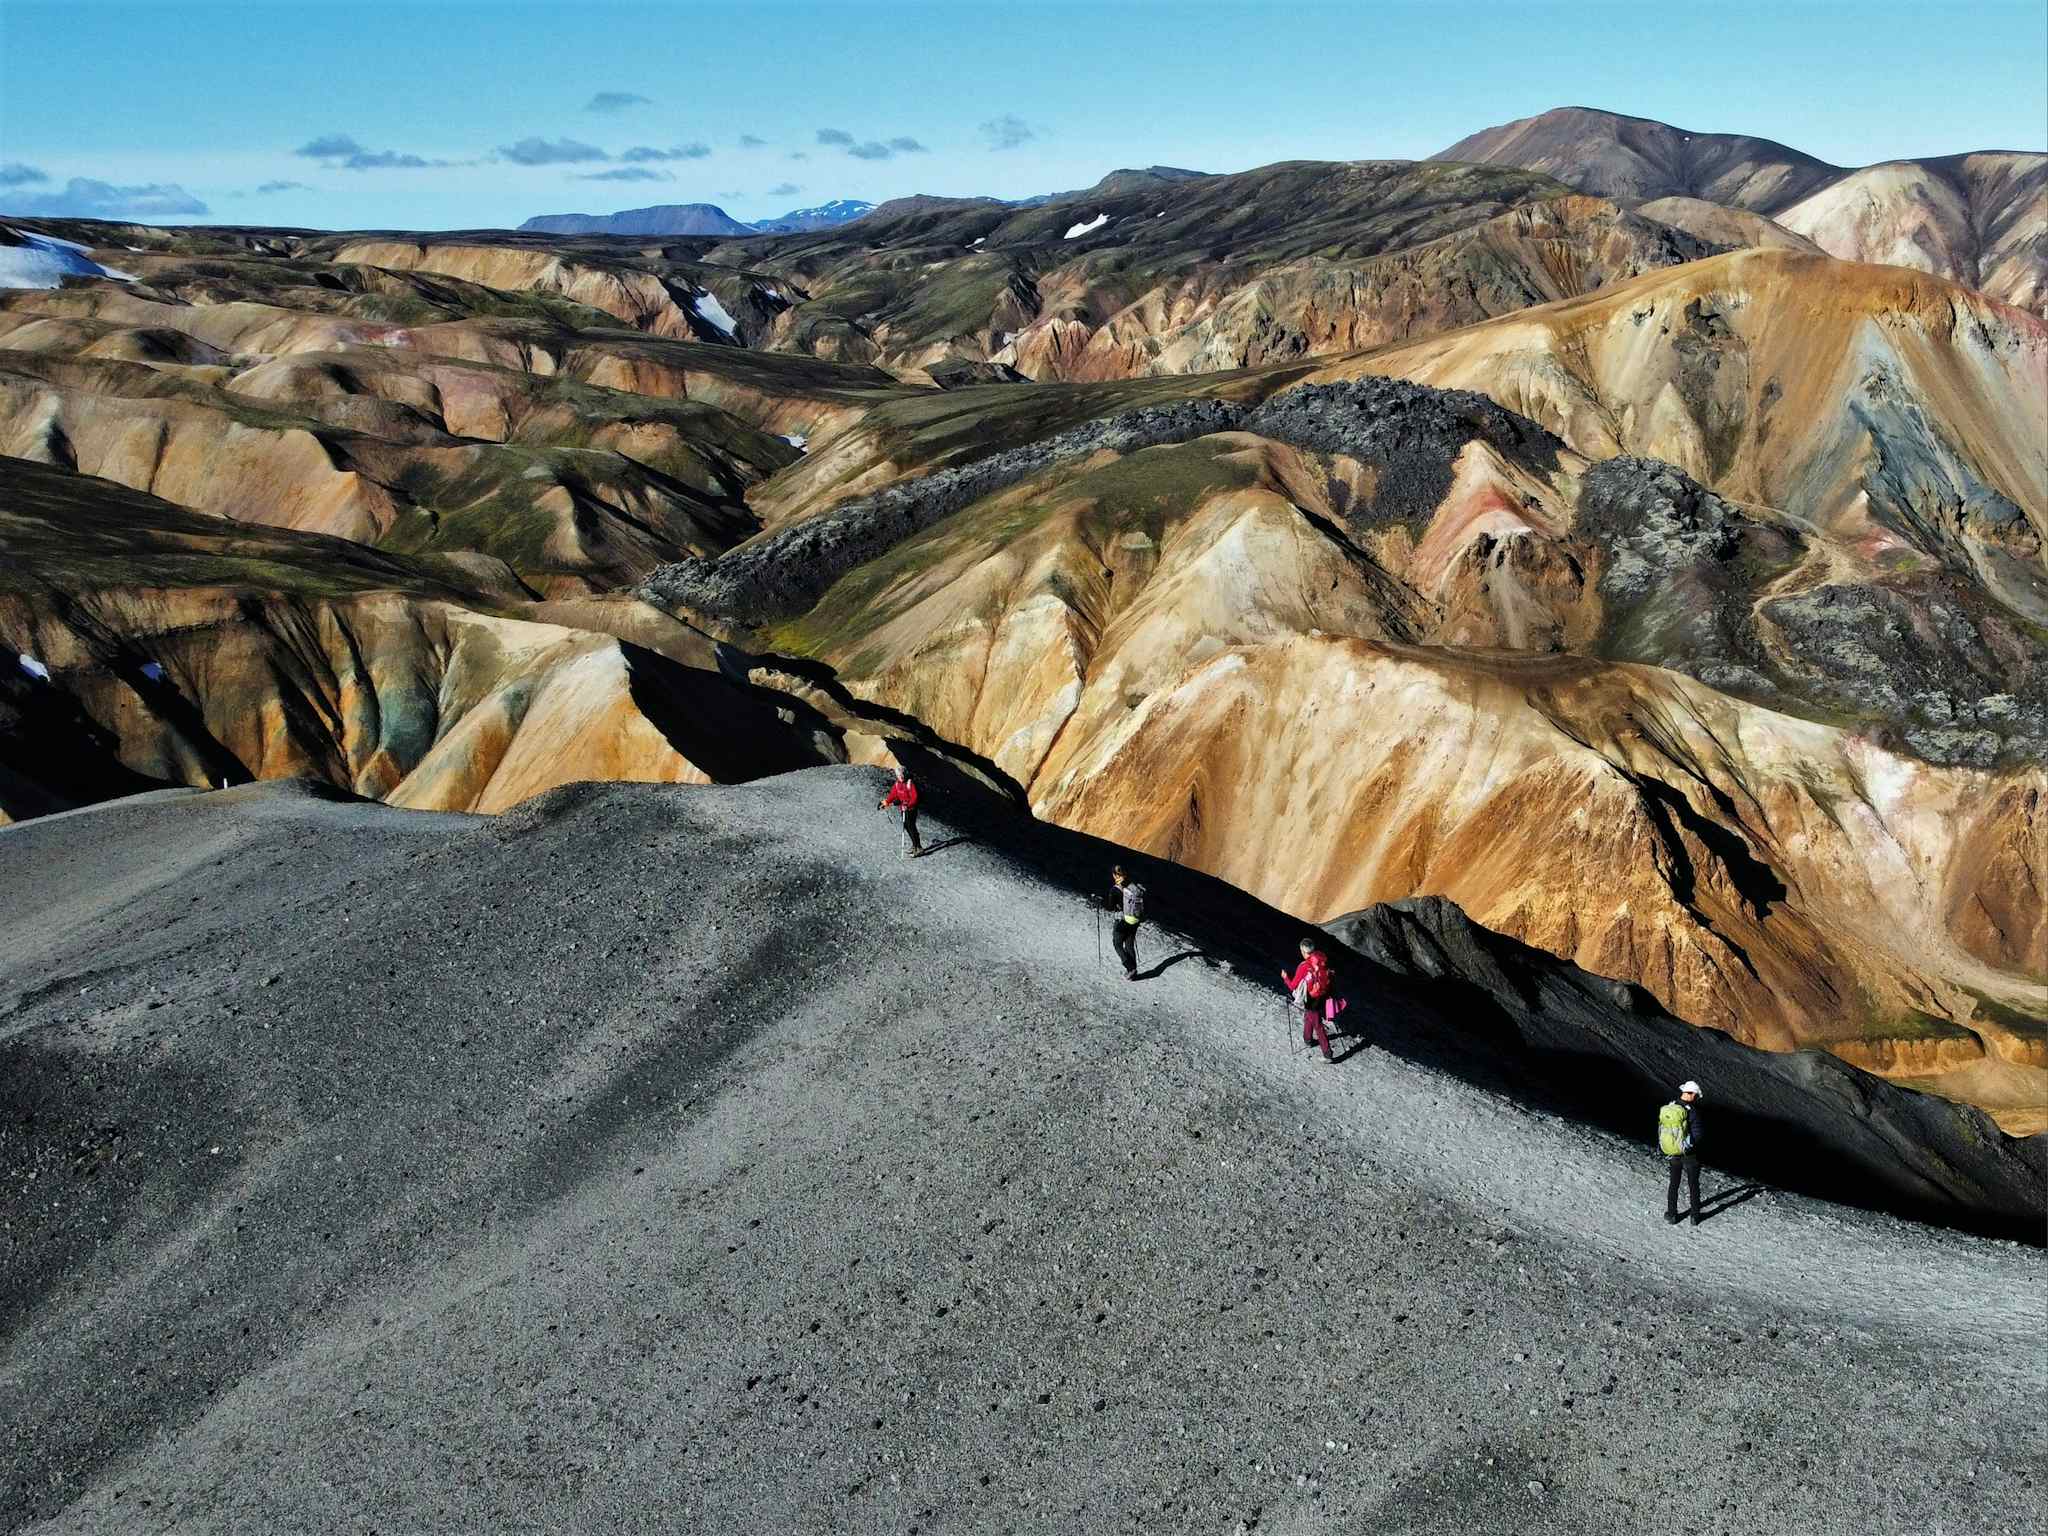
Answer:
0, 105, 2048, 1130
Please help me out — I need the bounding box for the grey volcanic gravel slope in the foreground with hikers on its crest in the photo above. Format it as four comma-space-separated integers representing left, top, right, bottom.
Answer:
0, 782, 2048, 1536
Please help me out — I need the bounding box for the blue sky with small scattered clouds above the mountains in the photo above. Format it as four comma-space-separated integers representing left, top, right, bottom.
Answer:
0, 0, 2048, 229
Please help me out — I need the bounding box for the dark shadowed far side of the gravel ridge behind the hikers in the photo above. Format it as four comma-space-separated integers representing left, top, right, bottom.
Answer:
909, 754, 2048, 1245
